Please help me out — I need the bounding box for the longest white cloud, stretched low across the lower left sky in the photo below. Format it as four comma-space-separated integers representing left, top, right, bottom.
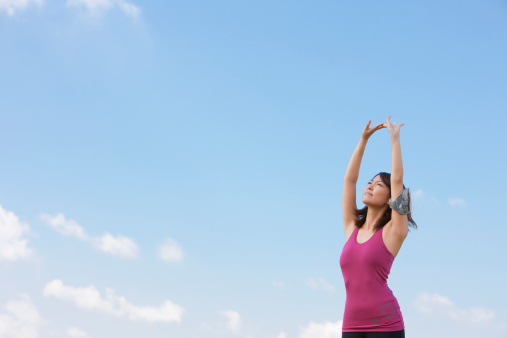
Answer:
43, 279, 185, 322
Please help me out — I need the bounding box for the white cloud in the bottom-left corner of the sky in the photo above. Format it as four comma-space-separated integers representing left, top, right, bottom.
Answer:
0, 294, 46, 338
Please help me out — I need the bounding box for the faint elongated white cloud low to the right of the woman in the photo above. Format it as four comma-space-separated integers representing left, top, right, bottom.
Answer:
414, 293, 495, 323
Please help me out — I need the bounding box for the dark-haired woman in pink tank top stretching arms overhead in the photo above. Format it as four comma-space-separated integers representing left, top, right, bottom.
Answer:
340, 116, 417, 338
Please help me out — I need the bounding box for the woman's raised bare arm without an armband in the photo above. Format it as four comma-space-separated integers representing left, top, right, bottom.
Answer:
342, 120, 385, 232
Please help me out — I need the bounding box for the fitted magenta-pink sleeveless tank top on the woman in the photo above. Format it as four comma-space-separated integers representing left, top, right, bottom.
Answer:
340, 227, 405, 332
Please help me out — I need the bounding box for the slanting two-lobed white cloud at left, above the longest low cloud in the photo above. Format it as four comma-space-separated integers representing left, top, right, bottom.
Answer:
40, 213, 139, 259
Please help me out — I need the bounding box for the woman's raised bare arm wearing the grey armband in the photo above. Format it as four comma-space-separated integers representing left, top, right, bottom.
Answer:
386, 116, 408, 238
